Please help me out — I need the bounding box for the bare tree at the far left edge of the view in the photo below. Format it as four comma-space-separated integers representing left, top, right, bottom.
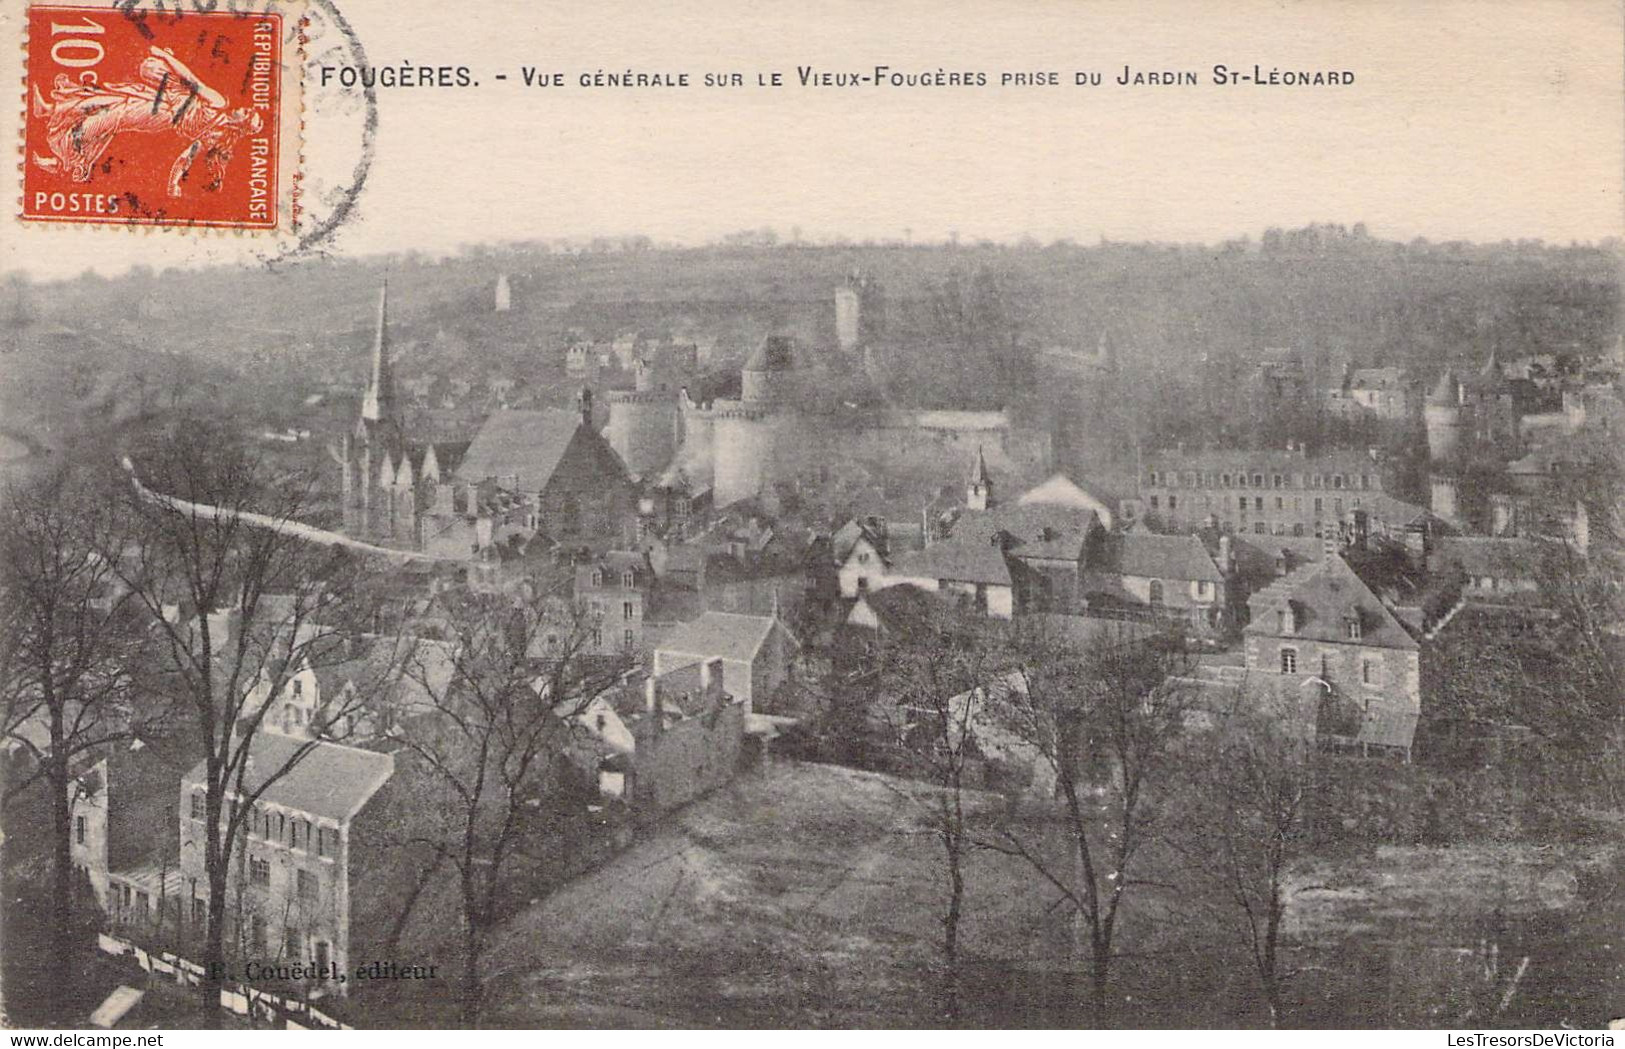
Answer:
0, 473, 150, 1015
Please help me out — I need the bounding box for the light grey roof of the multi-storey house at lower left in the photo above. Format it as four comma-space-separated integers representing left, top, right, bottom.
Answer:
185, 732, 395, 820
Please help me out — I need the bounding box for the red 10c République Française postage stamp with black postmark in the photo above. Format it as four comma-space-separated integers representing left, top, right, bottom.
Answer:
20, 3, 299, 231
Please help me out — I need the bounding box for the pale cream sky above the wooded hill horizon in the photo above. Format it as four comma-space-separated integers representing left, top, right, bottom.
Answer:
0, 0, 1625, 278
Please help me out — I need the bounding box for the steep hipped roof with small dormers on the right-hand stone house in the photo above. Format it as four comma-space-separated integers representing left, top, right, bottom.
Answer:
1245, 557, 1417, 650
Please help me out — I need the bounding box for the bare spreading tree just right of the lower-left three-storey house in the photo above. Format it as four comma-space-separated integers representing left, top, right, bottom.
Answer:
388, 578, 624, 1026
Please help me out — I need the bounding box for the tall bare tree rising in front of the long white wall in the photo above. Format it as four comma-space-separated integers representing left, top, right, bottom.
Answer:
104, 419, 380, 1015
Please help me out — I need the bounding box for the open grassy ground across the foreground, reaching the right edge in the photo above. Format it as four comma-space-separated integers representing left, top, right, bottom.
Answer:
451, 762, 1625, 1026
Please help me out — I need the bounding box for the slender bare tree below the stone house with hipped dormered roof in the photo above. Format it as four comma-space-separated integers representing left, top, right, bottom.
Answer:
1173, 690, 1318, 1026
